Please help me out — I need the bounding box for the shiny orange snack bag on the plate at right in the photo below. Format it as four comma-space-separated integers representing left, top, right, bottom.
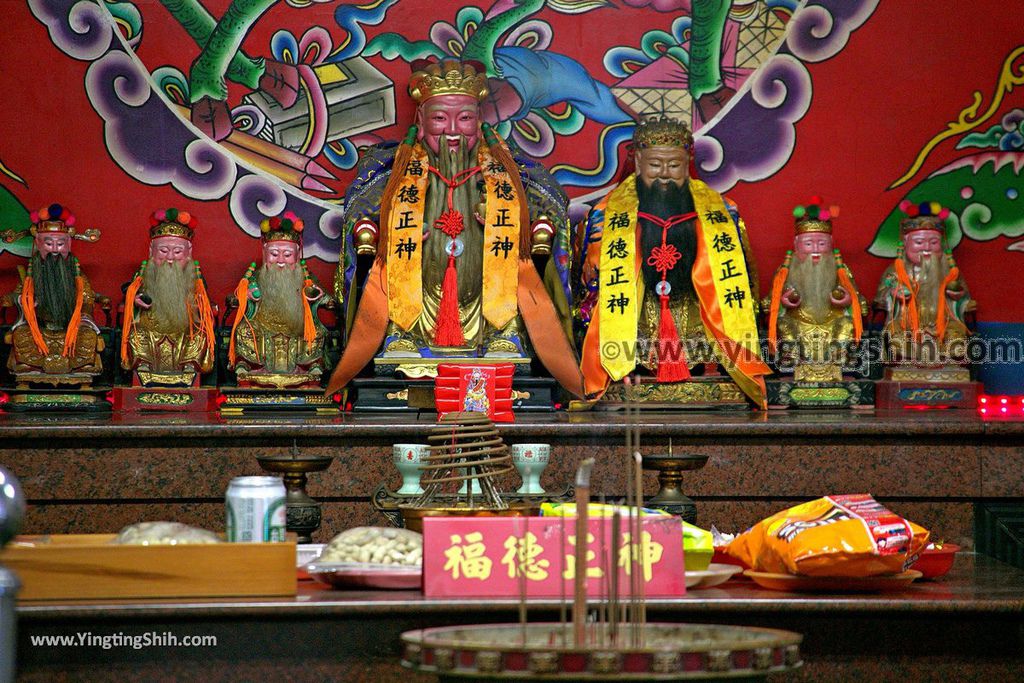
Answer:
726, 494, 929, 578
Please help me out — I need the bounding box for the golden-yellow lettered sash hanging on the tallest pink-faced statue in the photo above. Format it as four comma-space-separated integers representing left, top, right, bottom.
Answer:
381, 142, 522, 330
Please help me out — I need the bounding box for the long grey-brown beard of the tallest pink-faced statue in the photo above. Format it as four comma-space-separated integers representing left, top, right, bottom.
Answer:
423, 136, 483, 304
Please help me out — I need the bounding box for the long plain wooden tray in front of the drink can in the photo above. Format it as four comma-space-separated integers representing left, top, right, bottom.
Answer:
0, 533, 296, 600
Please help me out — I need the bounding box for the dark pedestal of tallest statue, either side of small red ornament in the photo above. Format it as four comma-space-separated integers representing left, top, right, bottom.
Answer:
348, 375, 559, 413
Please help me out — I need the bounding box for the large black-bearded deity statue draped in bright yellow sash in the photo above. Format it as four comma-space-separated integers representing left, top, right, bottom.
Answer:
583, 119, 770, 407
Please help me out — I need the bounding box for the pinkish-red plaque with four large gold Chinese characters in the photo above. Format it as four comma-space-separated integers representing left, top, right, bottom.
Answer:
423, 517, 686, 600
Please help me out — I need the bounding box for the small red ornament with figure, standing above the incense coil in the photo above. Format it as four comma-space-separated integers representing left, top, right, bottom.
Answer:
434, 364, 515, 422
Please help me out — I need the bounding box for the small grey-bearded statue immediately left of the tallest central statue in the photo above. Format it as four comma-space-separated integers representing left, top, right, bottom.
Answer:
228, 211, 331, 388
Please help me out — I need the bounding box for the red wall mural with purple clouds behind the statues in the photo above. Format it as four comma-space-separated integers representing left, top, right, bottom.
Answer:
0, 0, 1024, 321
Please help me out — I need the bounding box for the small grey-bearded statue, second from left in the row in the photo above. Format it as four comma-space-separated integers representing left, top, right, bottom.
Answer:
121, 209, 215, 387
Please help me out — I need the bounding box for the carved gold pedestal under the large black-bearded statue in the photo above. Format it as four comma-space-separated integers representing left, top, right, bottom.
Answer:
585, 377, 751, 411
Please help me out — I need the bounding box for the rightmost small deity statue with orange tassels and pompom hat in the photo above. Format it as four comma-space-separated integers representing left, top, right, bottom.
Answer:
874, 201, 976, 366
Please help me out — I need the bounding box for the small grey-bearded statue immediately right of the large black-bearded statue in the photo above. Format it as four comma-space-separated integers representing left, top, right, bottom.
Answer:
765, 197, 866, 382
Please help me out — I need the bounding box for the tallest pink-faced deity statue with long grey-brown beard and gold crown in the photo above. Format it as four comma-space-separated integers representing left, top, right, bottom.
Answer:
328, 60, 582, 401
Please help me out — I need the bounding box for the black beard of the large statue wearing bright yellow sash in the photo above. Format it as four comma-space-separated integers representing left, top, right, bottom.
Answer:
637, 178, 697, 299
